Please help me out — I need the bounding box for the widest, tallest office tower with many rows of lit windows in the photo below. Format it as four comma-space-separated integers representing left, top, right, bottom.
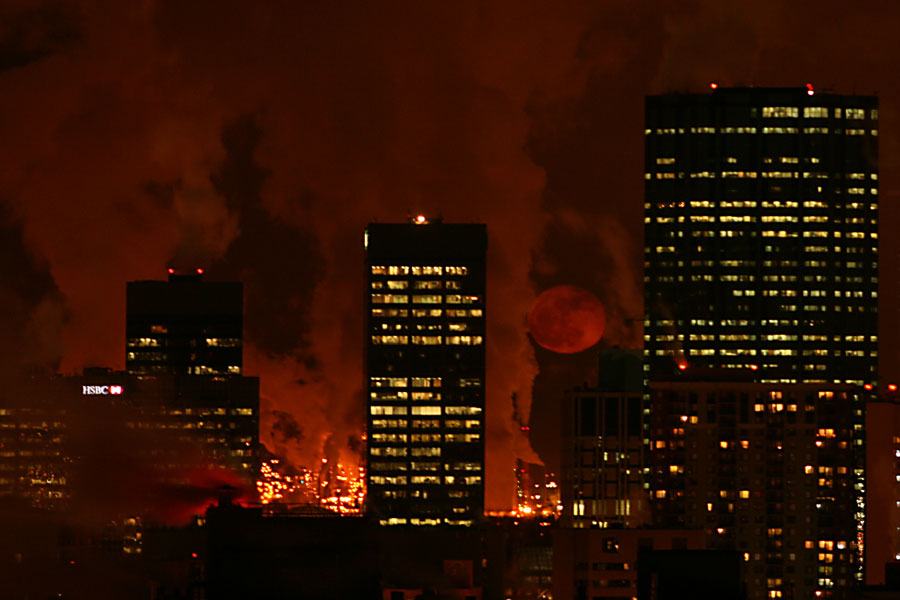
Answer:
644, 86, 878, 384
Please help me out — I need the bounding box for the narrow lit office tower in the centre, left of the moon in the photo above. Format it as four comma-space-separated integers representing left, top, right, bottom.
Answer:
364, 216, 487, 526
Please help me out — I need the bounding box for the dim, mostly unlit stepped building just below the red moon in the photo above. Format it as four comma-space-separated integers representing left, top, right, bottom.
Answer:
560, 350, 650, 528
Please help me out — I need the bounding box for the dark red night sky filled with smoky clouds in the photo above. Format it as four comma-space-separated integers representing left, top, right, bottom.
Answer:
0, 0, 900, 508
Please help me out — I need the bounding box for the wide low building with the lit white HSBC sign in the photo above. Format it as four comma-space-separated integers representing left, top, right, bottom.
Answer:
0, 369, 259, 508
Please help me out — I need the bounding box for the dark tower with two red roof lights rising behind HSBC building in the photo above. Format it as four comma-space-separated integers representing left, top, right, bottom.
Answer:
125, 269, 244, 375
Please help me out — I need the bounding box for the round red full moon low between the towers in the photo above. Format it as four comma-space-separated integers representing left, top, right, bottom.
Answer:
528, 285, 606, 354
